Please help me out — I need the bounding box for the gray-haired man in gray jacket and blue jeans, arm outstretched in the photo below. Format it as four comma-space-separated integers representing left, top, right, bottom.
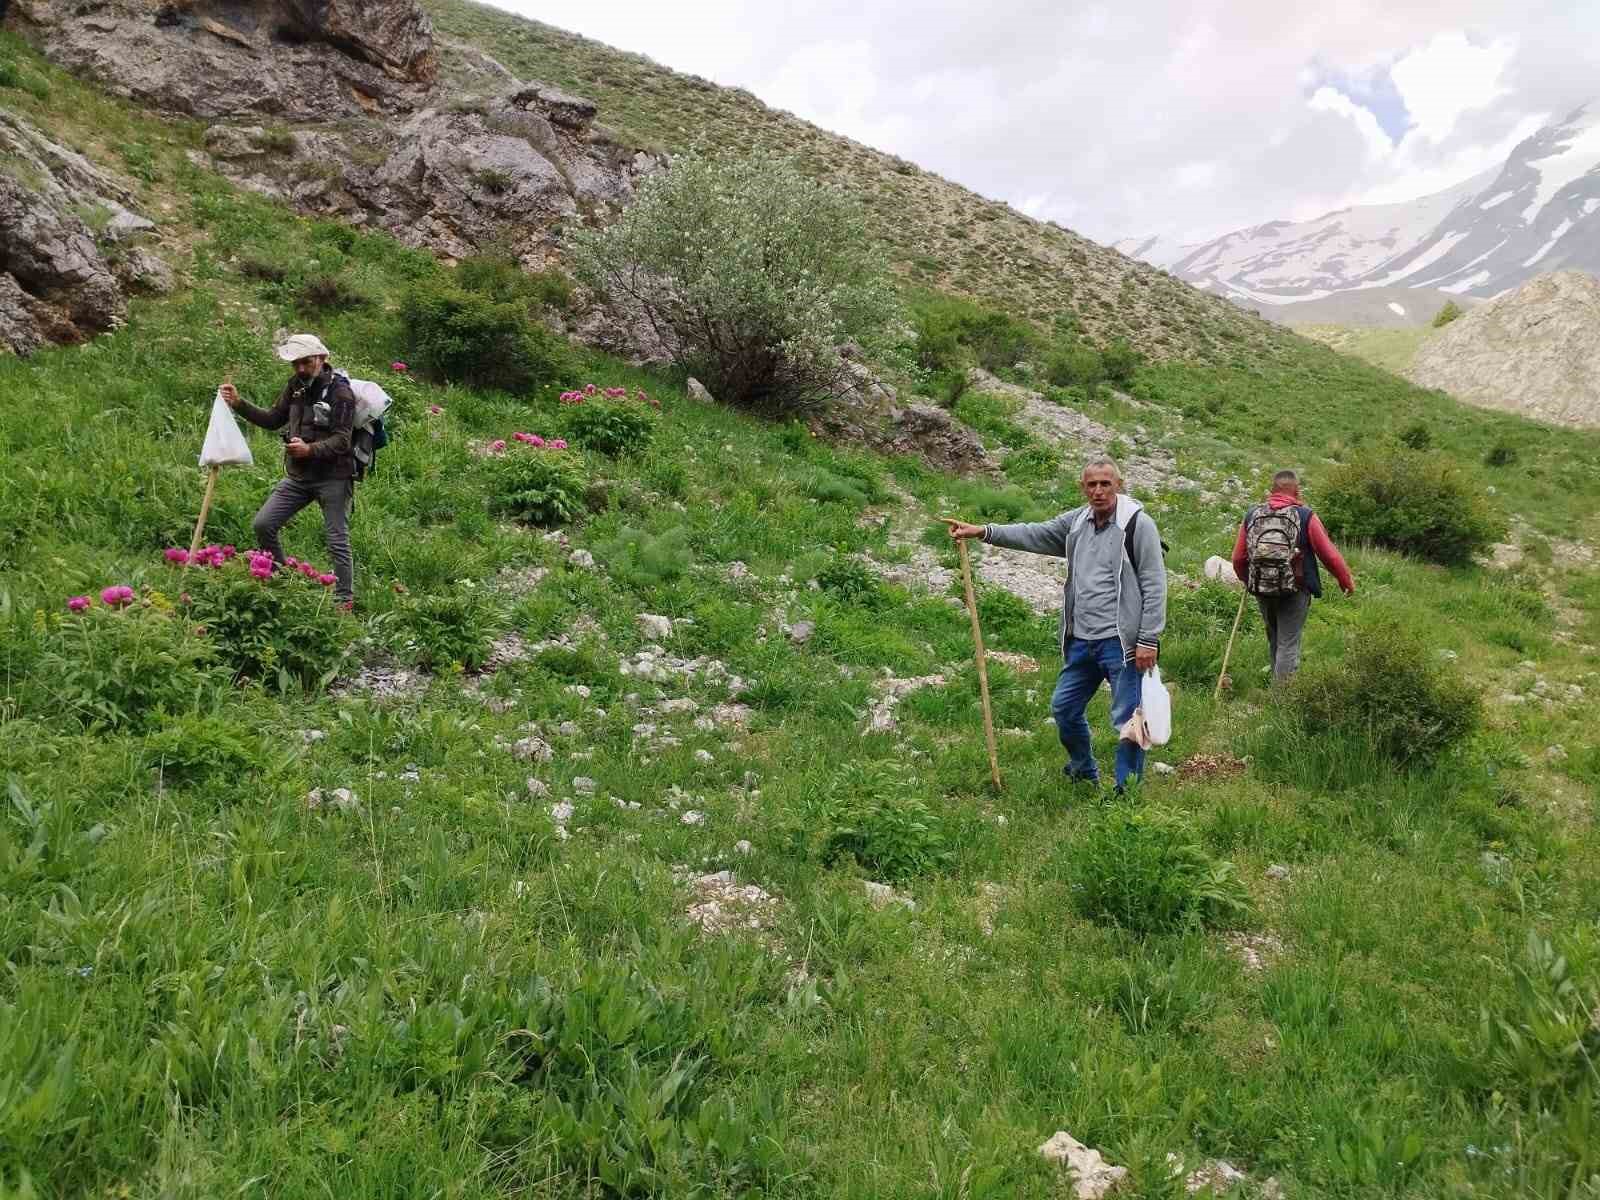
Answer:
946, 459, 1166, 792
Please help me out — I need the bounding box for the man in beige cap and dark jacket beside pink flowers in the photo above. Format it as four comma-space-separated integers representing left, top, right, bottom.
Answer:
222, 333, 355, 608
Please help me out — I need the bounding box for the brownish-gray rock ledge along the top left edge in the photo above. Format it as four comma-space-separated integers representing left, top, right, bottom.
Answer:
11, 0, 438, 122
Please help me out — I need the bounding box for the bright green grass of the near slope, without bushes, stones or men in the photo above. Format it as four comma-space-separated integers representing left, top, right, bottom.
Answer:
0, 25, 1600, 1197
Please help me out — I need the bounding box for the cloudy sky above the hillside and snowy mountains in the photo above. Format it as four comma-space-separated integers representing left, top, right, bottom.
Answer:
496, 0, 1600, 240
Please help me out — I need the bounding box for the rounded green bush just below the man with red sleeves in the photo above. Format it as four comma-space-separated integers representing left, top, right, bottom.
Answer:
1288, 621, 1483, 766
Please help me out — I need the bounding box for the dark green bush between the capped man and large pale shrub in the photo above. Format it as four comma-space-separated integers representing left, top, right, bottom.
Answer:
402, 282, 571, 392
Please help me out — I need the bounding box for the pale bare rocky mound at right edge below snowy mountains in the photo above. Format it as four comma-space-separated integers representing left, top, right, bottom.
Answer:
1410, 270, 1600, 426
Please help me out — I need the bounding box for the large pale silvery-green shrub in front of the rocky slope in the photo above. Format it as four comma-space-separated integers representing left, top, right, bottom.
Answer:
573, 154, 896, 413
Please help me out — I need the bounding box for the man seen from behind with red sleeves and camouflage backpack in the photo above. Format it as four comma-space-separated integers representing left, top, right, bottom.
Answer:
1234, 470, 1355, 683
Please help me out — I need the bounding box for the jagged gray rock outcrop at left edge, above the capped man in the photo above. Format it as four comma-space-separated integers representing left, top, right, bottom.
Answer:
0, 109, 170, 354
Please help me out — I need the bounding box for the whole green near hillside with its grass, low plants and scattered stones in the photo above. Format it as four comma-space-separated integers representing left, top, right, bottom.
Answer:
0, 18, 1600, 1200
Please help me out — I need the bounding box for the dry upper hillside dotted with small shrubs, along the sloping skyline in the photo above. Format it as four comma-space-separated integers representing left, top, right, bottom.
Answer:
424, 0, 1291, 362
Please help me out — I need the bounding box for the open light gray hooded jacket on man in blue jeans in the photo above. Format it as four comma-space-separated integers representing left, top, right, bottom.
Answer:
984, 496, 1166, 661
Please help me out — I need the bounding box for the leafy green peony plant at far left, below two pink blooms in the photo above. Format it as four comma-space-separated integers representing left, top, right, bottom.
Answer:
37, 594, 227, 730
